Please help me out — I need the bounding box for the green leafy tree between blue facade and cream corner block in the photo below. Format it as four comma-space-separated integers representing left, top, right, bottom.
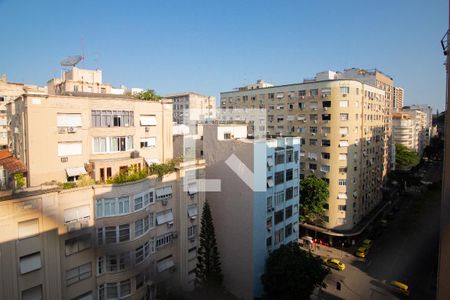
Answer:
300, 175, 329, 225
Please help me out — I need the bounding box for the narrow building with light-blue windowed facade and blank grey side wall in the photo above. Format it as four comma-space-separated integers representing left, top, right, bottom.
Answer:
203, 124, 300, 300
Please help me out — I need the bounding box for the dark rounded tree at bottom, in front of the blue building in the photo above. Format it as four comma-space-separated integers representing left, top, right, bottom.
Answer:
262, 243, 329, 300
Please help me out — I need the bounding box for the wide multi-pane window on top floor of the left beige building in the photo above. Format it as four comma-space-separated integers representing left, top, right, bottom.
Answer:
91, 110, 134, 127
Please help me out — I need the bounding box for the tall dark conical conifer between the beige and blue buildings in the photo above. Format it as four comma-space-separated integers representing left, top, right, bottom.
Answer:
195, 202, 223, 291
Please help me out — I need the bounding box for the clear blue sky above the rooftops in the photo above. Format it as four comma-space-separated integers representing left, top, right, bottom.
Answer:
0, 0, 448, 110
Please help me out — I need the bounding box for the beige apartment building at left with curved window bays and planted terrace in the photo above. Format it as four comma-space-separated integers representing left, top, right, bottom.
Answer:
0, 70, 204, 300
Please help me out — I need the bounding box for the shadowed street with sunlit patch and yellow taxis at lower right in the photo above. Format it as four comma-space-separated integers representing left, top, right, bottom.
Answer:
316, 165, 441, 299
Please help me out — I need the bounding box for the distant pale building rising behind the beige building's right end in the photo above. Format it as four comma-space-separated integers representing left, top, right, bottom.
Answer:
165, 92, 216, 124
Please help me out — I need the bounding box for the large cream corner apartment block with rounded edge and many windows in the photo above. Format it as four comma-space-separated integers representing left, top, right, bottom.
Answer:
220, 72, 391, 236
